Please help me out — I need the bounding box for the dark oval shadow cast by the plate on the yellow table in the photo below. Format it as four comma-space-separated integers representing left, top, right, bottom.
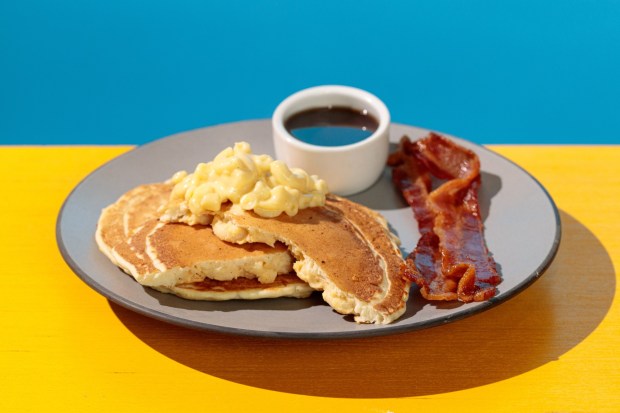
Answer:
110, 212, 616, 398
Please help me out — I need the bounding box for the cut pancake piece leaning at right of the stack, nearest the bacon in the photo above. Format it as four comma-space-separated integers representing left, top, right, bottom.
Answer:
212, 195, 410, 324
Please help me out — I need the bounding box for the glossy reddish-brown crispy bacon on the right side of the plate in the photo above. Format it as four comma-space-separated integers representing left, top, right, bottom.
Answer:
388, 133, 501, 302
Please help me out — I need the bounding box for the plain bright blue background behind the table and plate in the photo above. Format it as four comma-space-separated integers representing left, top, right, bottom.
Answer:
0, 0, 620, 144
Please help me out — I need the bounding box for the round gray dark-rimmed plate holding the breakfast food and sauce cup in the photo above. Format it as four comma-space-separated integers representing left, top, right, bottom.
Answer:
56, 120, 561, 338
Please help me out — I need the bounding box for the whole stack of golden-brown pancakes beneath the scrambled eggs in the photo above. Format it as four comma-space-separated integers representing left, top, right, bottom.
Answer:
96, 183, 410, 324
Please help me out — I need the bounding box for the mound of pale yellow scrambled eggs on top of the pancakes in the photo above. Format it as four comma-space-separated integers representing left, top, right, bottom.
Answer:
161, 142, 328, 225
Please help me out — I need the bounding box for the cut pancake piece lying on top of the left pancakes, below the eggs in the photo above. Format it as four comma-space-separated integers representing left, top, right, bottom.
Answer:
112, 219, 293, 287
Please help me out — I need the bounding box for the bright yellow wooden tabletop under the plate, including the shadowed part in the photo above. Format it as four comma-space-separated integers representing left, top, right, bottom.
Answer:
0, 146, 620, 412
